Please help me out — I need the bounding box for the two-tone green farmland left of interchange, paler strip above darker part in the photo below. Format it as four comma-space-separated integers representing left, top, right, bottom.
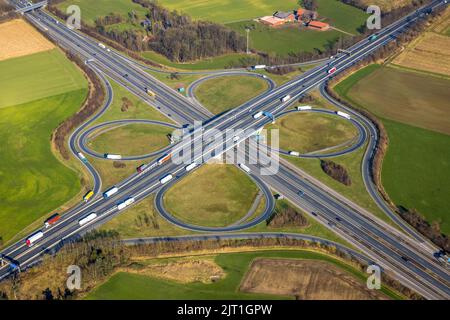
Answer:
0, 47, 88, 242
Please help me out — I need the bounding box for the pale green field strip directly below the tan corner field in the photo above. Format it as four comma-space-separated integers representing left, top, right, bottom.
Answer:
0, 49, 86, 108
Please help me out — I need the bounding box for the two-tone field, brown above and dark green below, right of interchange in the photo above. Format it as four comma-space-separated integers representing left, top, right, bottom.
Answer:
335, 66, 450, 234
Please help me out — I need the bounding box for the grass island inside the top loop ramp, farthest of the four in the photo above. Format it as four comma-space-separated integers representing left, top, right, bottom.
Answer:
195, 76, 267, 114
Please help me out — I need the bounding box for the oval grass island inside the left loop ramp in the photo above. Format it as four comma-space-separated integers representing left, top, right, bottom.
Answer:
89, 124, 173, 156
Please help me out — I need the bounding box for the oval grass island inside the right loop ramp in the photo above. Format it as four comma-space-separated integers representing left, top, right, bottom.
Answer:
266, 113, 357, 153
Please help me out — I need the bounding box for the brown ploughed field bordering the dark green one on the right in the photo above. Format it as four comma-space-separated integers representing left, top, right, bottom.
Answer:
336, 65, 450, 134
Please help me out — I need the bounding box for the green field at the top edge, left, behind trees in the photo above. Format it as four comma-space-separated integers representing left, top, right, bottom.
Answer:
57, 0, 147, 25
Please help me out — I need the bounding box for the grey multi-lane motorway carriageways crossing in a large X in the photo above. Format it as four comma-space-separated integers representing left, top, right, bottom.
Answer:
0, 1, 450, 299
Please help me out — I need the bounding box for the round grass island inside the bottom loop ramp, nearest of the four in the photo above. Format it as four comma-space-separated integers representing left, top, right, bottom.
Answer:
164, 164, 258, 227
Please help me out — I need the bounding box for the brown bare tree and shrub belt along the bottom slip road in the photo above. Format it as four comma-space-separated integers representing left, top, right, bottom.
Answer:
0, 231, 421, 300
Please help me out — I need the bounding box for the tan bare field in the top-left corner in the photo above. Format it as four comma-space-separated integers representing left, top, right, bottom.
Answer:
0, 19, 55, 61
